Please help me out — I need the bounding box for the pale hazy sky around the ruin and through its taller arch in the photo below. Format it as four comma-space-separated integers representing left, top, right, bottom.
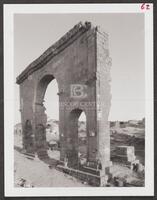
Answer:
14, 13, 145, 123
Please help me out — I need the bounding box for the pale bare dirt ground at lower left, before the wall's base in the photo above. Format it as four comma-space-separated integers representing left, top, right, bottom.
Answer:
14, 150, 86, 187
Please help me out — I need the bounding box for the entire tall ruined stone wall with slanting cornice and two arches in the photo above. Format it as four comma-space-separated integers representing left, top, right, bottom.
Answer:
17, 22, 111, 185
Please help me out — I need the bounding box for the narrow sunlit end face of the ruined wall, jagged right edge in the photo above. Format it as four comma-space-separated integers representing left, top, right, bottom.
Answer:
96, 29, 111, 169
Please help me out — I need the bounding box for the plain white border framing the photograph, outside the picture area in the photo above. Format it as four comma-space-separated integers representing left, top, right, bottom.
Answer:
3, 3, 154, 197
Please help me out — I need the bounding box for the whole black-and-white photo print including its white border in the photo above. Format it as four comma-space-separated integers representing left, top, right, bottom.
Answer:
4, 3, 154, 196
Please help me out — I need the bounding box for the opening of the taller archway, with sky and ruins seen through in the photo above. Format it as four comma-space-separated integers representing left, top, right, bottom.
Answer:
44, 79, 60, 159
